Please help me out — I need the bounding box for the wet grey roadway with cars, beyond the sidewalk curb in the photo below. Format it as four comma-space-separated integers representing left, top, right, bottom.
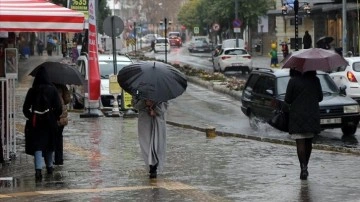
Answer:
146, 44, 360, 153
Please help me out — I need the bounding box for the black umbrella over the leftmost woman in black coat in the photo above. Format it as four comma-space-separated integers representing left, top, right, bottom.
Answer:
30, 62, 84, 85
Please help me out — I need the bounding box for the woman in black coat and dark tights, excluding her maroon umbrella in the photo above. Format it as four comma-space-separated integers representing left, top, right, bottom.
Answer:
285, 71, 323, 180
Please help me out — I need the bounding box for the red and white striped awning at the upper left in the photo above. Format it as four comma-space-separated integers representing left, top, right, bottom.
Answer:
0, 0, 84, 32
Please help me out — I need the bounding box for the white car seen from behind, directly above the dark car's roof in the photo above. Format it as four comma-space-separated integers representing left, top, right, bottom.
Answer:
213, 48, 252, 73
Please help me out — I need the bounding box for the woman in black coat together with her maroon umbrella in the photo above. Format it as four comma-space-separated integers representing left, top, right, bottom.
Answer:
283, 48, 348, 180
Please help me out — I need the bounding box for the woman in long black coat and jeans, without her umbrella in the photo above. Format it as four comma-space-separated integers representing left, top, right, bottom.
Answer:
23, 67, 62, 180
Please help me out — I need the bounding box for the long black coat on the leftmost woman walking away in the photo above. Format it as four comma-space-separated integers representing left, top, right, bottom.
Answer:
23, 67, 62, 151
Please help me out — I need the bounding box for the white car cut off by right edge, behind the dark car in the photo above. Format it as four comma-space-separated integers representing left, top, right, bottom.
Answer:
330, 57, 360, 103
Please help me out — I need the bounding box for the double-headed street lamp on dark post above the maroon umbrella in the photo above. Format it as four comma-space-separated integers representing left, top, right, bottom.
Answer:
281, 0, 311, 51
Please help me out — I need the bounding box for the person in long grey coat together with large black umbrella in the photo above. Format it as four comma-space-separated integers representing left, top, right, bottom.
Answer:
117, 62, 187, 178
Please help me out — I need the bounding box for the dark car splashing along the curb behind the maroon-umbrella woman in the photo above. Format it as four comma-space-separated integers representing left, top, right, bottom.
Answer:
241, 68, 360, 135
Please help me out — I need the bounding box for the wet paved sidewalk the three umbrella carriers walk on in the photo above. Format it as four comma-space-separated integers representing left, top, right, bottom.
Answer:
0, 56, 360, 202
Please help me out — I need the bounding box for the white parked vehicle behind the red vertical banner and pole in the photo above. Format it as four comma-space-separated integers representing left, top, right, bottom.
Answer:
71, 54, 133, 110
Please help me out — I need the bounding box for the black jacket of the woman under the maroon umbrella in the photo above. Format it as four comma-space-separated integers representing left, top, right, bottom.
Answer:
285, 72, 323, 134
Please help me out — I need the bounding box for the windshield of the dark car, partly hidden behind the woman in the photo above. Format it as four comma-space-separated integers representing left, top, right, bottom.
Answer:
277, 74, 339, 96
